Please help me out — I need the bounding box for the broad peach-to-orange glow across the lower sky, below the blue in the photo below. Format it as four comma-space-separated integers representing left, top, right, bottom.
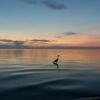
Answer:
0, 34, 100, 47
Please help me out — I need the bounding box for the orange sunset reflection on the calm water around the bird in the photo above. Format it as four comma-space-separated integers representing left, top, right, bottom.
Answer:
0, 49, 100, 68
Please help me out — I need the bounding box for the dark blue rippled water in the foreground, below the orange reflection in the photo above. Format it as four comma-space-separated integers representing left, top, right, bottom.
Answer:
0, 70, 100, 100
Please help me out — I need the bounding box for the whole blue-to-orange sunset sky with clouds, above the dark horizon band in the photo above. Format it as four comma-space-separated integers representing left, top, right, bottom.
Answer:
0, 0, 100, 47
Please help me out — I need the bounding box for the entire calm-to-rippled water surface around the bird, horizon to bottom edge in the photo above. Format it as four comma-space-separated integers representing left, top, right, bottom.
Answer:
0, 49, 100, 100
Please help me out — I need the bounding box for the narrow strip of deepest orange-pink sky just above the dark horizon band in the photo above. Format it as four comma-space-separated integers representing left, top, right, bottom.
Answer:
24, 41, 100, 47
